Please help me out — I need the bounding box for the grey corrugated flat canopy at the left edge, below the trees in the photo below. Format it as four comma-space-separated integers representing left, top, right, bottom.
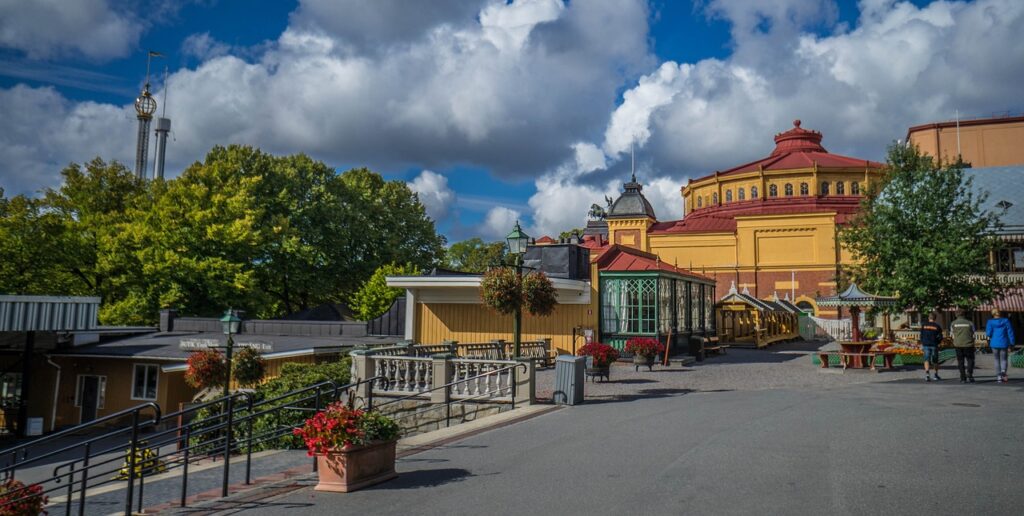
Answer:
0, 296, 99, 332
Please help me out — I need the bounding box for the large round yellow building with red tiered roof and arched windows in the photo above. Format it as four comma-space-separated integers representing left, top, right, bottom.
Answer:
607, 120, 883, 315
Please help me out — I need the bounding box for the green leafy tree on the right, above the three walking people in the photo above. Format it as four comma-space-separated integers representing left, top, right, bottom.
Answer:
840, 144, 1006, 312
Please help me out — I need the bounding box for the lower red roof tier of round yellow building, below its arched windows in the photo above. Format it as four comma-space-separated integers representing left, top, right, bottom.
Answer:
648, 196, 860, 234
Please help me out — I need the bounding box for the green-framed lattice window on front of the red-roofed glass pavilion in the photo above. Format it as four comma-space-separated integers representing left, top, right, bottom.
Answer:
601, 277, 657, 335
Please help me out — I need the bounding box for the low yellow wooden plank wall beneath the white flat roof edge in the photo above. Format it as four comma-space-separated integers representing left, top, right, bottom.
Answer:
415, 303, 597, 352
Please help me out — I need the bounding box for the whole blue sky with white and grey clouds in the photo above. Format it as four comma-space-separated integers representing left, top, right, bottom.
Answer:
0, 0, 1024, 242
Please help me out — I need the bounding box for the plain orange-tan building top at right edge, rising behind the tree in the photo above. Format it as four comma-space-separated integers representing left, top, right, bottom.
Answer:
906, 117, 1024, 168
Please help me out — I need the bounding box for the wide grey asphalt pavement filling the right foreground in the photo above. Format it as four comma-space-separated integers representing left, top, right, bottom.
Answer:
216, 370, 1024, 516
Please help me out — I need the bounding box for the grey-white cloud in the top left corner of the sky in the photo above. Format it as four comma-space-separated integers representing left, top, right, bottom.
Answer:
0, 0, 143, 59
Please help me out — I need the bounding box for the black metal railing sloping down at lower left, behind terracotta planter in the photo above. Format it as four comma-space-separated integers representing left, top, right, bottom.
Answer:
0, 377, 387, 515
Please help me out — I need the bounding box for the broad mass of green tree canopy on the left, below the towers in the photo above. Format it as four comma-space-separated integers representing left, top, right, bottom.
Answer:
0, 145, 444, 324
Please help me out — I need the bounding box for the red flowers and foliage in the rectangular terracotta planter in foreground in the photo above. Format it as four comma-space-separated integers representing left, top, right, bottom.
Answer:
292, 401, 400, 457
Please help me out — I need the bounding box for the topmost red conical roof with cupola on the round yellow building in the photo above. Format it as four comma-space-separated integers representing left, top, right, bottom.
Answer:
695, 120, 884, 181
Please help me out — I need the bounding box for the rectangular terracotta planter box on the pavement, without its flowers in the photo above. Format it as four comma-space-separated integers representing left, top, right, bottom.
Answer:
314, 440, 398, 492
